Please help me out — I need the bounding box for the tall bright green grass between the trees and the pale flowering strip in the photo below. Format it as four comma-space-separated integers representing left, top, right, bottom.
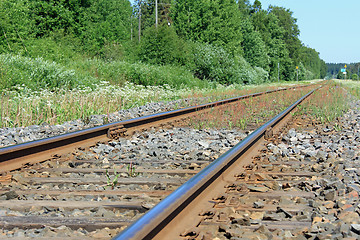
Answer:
0, 54, 210, 90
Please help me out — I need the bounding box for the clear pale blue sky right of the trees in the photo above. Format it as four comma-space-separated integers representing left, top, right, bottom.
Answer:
251, 0, 360, 63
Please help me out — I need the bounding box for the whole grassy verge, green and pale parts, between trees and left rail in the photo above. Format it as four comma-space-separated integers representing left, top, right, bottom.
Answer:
0, 54, 322, 128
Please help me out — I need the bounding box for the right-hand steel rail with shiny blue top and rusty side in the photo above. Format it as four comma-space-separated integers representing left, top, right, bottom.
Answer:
114, 86, 322, 240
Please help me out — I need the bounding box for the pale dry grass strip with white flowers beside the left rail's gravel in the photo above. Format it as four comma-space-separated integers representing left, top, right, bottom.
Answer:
0, 82, 316, 128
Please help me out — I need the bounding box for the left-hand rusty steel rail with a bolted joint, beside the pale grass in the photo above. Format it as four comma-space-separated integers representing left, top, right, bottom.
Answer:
0, 85, 309, 172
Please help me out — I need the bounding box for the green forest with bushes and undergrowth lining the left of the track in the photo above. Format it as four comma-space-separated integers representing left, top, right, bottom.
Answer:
0, 0, 327, 89
